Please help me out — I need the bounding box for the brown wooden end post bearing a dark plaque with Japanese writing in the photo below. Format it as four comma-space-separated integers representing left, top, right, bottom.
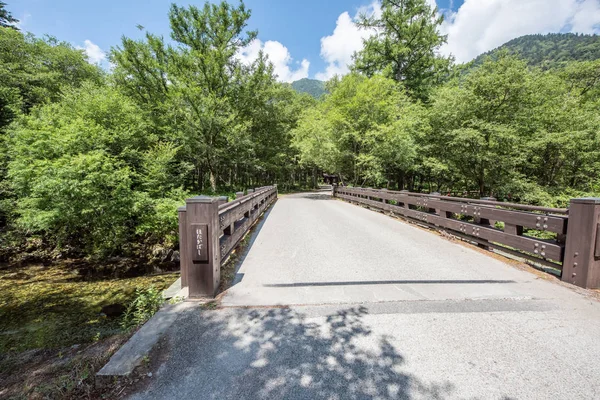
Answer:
185, 196, 221, 297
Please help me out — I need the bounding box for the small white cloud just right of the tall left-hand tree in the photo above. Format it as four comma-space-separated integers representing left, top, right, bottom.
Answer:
237, 39, 310, 82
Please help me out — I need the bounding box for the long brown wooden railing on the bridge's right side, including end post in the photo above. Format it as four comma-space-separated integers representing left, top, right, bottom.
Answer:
333, 186, 600, 288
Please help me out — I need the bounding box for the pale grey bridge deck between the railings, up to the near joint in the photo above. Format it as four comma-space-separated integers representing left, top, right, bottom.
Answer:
223, 193, 556, 306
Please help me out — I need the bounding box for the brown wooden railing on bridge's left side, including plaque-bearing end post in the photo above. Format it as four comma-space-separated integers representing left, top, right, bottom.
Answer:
178, 186, 277, 297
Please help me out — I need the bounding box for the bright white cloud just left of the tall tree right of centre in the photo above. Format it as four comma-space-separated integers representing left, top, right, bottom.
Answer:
315, 1, 381, 81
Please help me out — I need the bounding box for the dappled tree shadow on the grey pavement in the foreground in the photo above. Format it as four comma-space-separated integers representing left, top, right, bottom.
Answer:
133, 307, 453, 399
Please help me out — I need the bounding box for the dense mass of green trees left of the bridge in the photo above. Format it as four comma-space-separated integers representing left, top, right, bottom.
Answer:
0, 2, 315, 259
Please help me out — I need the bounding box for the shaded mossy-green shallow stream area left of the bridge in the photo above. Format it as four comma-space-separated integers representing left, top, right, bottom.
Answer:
0, 264, 177, 354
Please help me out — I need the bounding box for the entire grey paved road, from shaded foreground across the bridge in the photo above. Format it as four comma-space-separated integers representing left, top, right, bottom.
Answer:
133, 193, 600, 399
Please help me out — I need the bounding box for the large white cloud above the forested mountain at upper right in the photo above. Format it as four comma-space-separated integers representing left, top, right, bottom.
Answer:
441, 0, 600, 62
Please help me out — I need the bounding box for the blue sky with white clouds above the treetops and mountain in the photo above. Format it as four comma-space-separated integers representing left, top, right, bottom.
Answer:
5, 0, 600, 81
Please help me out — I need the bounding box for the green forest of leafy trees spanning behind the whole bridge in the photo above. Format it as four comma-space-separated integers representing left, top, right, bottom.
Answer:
0, 0, 600, 261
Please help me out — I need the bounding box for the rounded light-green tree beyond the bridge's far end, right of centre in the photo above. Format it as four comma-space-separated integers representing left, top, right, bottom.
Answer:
294, 74, 424, 185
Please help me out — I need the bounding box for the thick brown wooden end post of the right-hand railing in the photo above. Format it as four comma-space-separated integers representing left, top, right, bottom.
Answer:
562, 197, 600, 289
